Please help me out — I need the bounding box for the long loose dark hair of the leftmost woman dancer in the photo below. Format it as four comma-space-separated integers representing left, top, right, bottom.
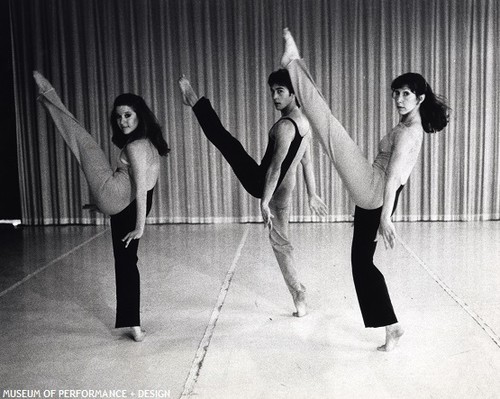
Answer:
109, 93, 170, 156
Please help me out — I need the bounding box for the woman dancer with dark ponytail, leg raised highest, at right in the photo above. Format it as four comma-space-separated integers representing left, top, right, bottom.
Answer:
281, 28, 448, 351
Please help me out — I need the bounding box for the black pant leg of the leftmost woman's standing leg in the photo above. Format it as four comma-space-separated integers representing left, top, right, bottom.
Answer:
111, 189, 153, 328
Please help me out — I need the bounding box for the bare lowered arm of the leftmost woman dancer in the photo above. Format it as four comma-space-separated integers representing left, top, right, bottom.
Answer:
122, 140, 150, 247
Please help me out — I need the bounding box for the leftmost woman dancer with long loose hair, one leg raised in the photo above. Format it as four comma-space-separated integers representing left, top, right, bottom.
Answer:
33, 71, 170, 342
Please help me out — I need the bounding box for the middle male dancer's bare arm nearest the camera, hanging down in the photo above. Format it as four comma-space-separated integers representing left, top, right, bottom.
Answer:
260, 120, 295, 228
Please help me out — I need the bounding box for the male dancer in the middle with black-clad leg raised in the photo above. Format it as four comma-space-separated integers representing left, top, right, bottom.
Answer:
179, 69, 326, 317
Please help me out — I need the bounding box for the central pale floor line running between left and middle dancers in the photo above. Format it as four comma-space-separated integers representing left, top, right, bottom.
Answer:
180, 226, 248, 398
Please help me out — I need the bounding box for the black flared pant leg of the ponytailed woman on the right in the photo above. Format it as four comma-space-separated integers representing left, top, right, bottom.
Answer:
351, 186, 403, 327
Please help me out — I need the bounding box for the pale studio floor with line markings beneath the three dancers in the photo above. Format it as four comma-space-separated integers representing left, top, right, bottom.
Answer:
0, 222, 500, 399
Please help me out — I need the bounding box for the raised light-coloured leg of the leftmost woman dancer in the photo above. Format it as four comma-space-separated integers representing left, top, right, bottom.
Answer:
33, 71, 134, 215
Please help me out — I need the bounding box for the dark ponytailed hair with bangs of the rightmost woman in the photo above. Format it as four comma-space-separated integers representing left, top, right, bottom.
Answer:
391, 72, 450, 133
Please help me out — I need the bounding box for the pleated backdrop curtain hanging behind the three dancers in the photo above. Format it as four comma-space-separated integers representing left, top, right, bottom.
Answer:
10, 0, 500, 224
